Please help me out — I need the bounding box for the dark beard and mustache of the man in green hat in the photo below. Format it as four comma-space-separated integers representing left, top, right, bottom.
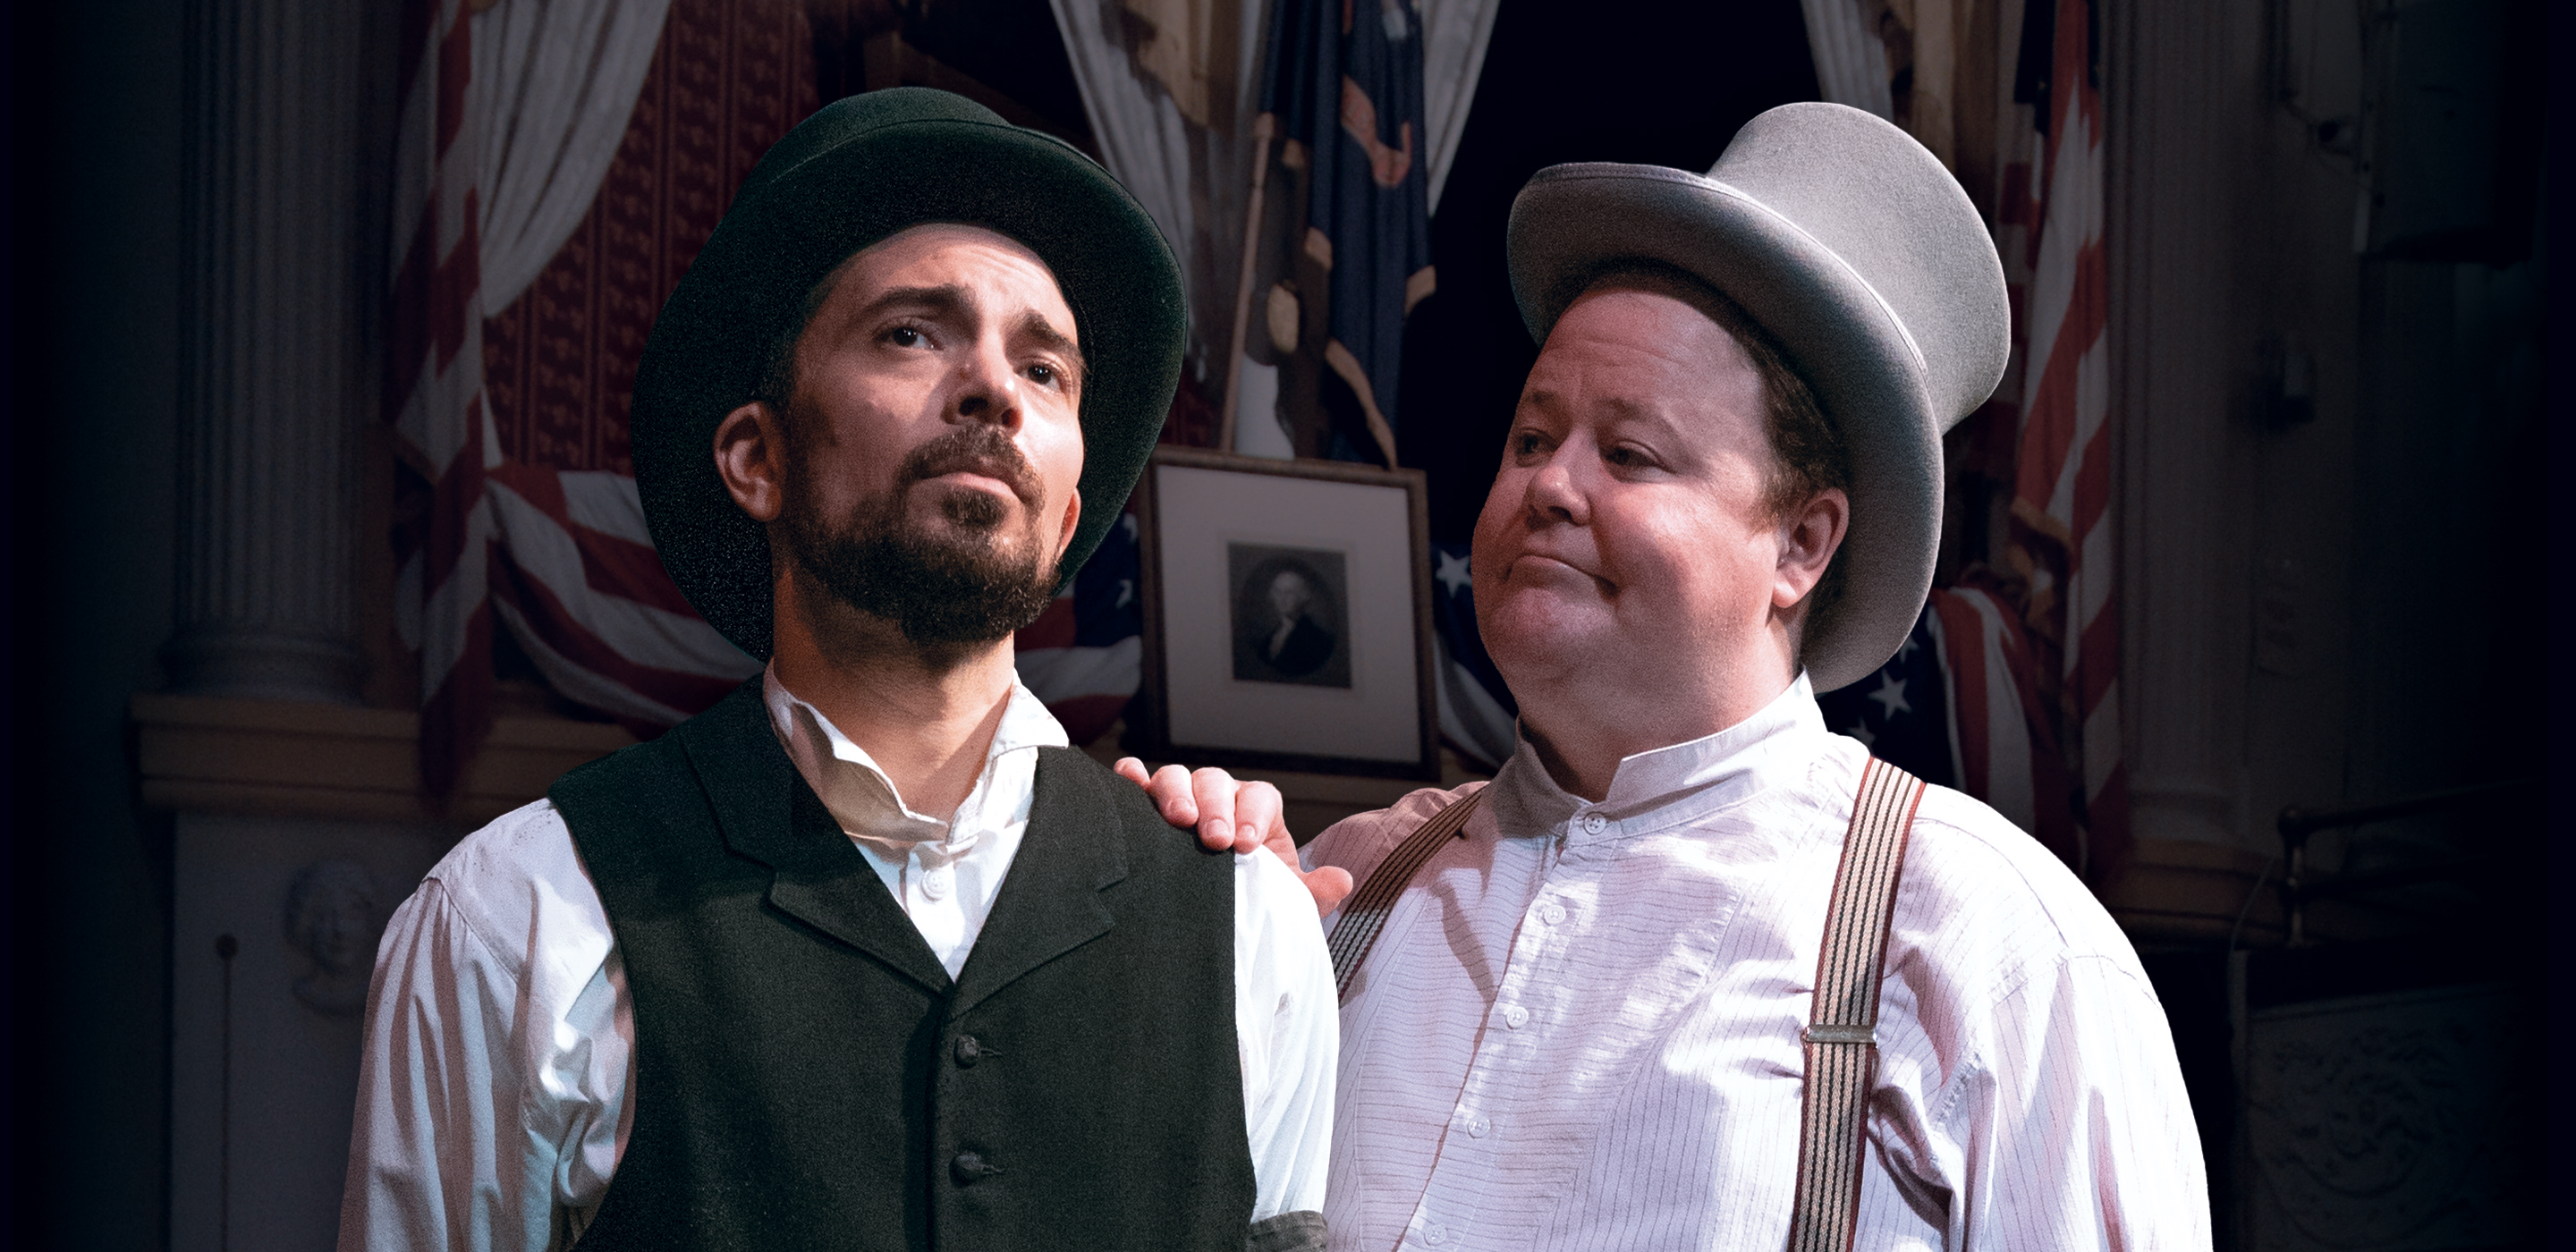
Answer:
781, 418, 1056, 644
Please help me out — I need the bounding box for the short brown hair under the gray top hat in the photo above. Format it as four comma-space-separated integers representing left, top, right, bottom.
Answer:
1579, 258, 1852, 634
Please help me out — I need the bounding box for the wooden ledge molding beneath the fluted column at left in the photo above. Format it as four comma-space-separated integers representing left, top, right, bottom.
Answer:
131, 693, 636, 827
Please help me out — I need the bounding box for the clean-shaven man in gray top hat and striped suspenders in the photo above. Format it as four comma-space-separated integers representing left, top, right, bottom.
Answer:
1159, 103, 2210, 1252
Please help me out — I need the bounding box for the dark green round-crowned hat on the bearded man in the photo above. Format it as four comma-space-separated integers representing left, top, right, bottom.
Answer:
633, 88, 1191, 659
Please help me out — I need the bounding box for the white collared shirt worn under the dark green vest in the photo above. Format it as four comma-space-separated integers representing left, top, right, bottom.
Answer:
340, 678, 1337, 1252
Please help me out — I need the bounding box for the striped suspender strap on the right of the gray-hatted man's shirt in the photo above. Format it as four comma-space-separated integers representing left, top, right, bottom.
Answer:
1788, 757, 1924, 1252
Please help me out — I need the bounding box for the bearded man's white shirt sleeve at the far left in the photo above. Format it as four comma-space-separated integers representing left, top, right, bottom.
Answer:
340, 801, 633, 1252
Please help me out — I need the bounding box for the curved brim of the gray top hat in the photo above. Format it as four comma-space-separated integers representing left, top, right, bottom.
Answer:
1507, 162, 1943, 690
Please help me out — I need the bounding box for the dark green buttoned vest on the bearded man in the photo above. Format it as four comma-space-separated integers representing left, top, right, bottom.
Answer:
551, 680, 1252, 1252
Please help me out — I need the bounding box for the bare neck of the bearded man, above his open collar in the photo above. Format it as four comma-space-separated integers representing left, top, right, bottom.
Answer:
770, 577, 1015, 819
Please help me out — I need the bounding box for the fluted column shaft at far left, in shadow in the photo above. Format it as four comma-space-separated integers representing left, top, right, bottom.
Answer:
162, 0, 381, 703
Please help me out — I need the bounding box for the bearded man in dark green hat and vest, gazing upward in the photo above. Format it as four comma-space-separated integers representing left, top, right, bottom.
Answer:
340, 90, 1335, 1252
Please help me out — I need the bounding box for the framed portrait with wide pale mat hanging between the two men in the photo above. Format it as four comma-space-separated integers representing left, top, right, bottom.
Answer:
1128, 445, 1440, 778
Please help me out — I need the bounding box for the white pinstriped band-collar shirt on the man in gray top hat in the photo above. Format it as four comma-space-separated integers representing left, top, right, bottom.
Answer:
1309, 675, 2210, 1252
